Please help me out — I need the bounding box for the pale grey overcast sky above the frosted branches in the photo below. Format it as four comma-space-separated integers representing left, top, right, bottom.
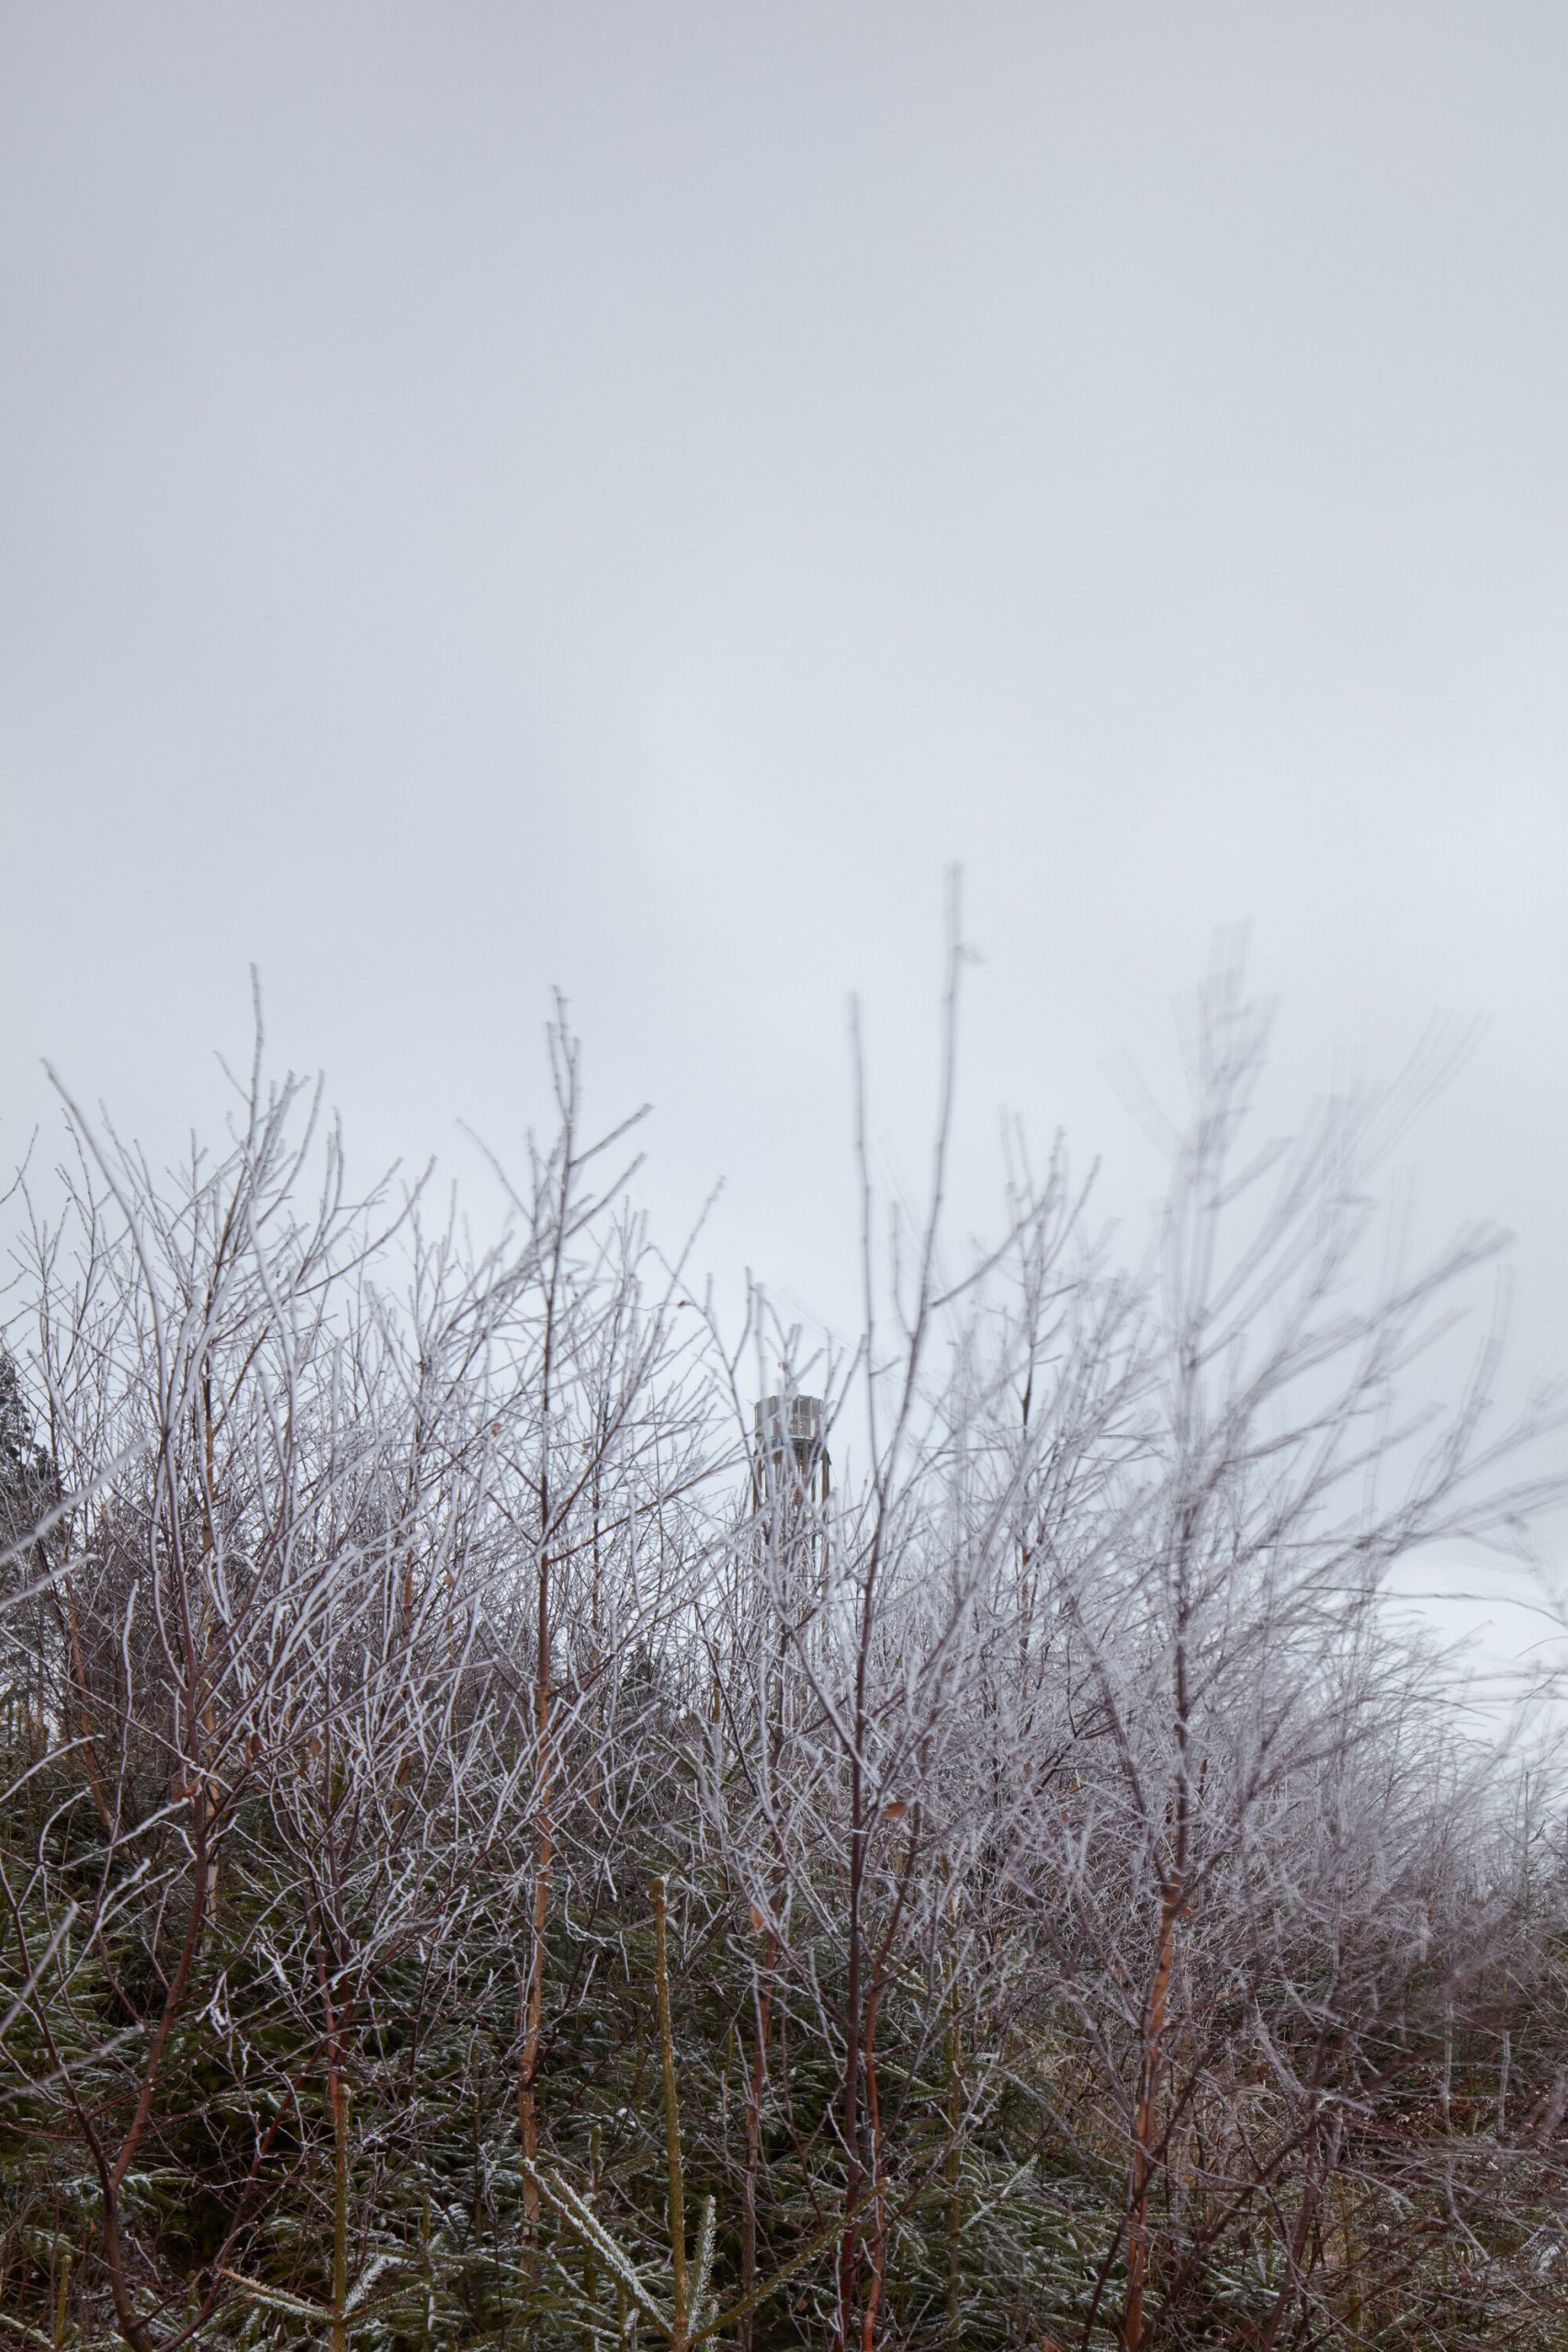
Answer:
0, 0, 1568, 1543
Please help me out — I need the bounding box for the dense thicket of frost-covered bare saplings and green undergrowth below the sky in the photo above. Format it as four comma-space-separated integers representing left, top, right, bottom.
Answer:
0, 978, 1568, 2352
